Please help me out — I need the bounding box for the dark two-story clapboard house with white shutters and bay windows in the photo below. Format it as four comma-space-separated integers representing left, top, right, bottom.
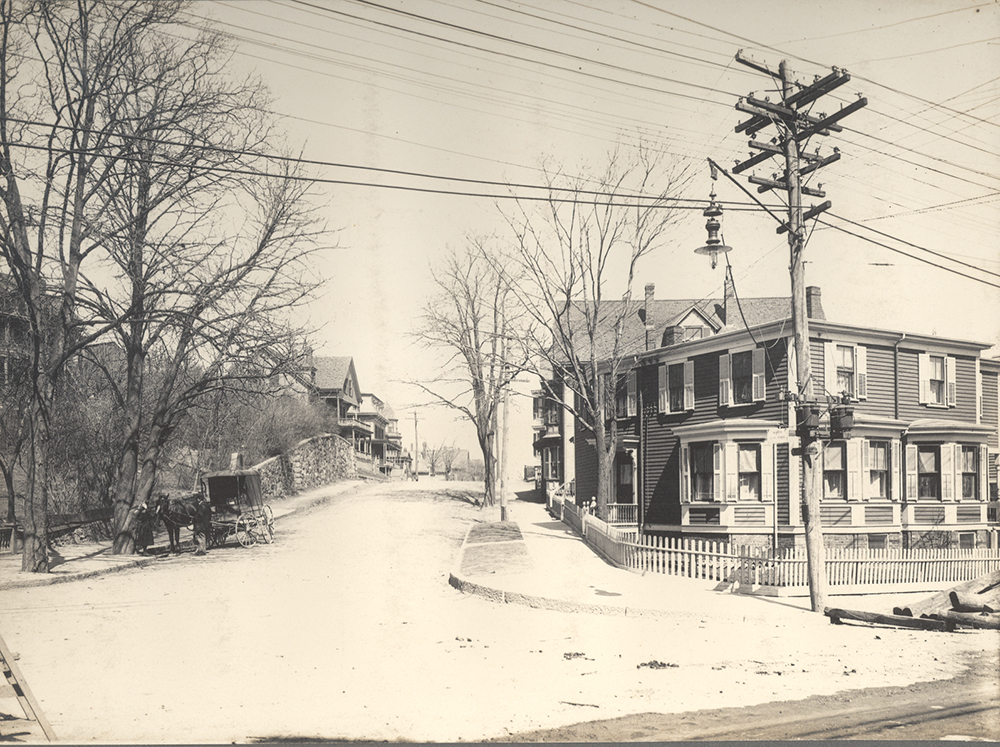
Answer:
548, 288, 1000, 548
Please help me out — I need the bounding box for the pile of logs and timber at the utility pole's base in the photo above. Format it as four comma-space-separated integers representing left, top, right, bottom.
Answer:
823, 571, 1000, 631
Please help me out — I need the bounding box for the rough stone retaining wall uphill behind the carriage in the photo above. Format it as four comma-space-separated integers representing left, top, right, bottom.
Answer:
253, 433, 358, 500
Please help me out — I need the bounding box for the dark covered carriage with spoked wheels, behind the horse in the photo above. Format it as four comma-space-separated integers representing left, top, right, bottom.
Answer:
198, 469, 274, 547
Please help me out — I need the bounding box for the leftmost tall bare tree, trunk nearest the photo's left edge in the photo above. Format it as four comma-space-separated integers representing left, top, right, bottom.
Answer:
0, 0, 197, 572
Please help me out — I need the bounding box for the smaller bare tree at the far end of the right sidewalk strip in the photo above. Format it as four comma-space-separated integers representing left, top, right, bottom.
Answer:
414, 238, 531, 506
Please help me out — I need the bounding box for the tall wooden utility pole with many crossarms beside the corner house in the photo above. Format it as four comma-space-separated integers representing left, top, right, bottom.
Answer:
733, 51, 868, 612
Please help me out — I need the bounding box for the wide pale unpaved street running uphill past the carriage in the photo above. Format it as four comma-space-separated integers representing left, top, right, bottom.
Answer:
0, 483, 998, 742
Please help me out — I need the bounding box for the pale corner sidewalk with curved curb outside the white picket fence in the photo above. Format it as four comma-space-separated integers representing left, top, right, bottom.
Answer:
449, 501, 928, 618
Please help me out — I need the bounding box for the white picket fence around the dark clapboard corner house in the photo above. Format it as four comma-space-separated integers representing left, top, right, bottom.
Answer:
553, 501, 1000, 596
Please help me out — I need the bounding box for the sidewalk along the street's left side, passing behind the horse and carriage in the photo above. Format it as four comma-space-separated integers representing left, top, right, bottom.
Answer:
0, 480, 369, 590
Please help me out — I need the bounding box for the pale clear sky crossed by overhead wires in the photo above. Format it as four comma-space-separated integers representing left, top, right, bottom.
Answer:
189, 0, 1000, 472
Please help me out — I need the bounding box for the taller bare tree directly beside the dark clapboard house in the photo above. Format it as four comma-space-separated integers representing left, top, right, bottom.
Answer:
497, 143, 687, 517
